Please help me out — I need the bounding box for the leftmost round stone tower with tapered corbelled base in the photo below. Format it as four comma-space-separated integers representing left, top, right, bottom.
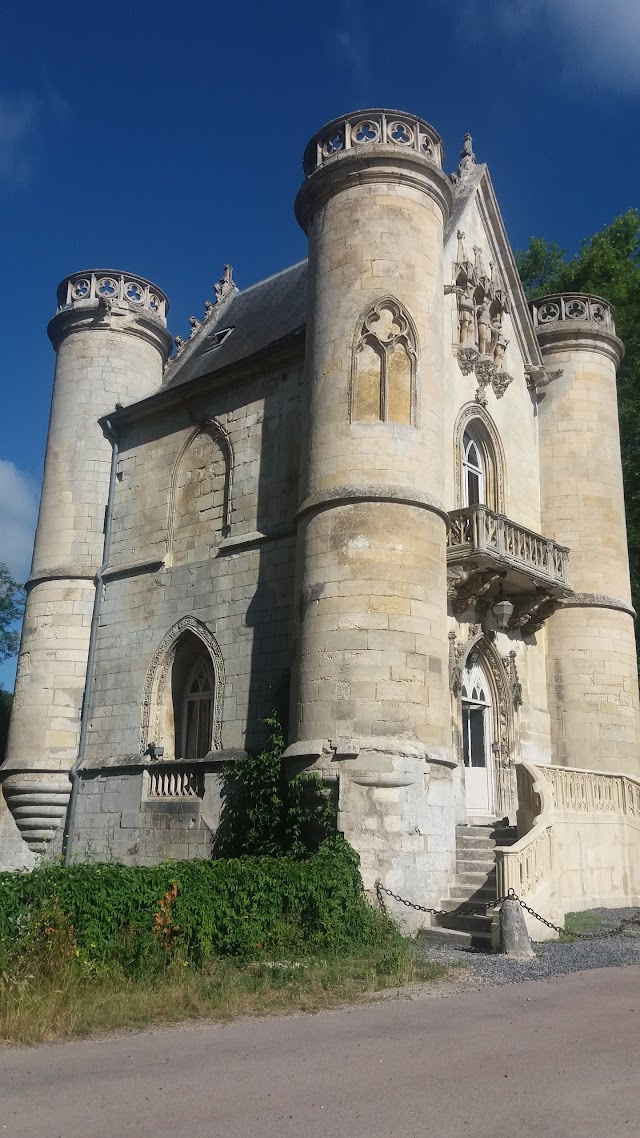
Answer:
2, 270, 171, 850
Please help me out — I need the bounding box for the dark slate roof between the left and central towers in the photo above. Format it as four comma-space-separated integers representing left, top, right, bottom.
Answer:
164, 261, 307, 390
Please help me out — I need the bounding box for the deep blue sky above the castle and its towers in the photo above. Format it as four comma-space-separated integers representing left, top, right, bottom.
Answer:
0, 0, 640, 686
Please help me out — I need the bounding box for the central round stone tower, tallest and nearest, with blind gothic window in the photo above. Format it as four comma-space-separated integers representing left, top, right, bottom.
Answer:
287, 109, 454, 899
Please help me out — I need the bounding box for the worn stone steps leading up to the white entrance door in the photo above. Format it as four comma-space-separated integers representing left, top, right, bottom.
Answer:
422, 822, 518, 950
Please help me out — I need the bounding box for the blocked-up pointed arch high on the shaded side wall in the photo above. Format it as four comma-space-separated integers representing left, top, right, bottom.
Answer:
165, 419, 233, 564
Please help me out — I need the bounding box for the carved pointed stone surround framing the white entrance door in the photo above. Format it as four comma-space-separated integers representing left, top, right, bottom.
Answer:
450, 625, 520, 815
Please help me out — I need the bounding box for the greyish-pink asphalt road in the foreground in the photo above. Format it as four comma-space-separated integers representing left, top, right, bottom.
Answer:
0, 966, 640, 1138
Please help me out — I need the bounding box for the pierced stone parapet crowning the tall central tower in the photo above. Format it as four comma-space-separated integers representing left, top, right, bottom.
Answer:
303, 108, 443, 178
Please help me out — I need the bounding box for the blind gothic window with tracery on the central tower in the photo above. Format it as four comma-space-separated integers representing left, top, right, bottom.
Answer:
350, 296, 418, 427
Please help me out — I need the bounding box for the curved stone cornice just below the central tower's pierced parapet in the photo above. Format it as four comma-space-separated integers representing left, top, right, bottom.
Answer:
295, 142, 454, 232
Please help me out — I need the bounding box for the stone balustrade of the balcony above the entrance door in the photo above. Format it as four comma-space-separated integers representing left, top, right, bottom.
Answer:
446, 505, 569, 588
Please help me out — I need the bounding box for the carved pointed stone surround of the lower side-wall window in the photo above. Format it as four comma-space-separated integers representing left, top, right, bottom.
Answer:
140, 617, 224, 758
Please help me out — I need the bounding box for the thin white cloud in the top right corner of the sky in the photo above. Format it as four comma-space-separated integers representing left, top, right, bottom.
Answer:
459, 0, 640, 91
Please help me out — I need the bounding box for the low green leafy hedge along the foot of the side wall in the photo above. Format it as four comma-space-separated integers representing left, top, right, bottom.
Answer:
0, 838, 397, 974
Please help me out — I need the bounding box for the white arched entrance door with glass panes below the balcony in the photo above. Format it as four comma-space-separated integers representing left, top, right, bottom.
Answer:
460, 652, 495, 817
